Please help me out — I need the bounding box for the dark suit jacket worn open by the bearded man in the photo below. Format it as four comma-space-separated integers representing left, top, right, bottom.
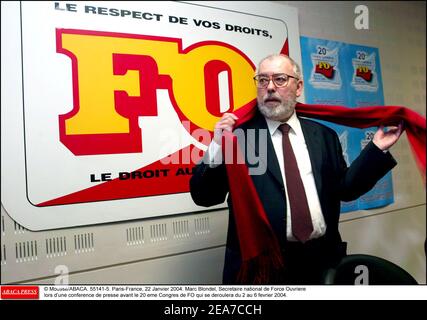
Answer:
190, 112, 396, 284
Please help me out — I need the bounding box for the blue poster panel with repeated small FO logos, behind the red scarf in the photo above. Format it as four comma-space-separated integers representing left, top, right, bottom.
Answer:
301, 37, 394, 213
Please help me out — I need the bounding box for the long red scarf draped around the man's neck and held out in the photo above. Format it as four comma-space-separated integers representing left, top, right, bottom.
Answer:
223, 100, 426, 284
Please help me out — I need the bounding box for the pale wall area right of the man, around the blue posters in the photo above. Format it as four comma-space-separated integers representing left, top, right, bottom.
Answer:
280, 1, 426, 283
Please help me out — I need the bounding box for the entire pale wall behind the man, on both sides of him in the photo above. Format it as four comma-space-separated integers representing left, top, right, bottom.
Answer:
0, 1, 426, 284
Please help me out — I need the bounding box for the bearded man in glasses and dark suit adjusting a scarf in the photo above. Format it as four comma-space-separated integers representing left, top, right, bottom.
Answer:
190, 55, 402, 284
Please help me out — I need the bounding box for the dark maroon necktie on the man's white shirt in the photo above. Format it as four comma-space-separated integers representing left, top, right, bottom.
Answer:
279, 123, 313, 242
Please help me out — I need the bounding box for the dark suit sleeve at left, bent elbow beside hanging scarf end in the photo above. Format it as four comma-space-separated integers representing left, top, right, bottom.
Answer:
190, 154, 229, 207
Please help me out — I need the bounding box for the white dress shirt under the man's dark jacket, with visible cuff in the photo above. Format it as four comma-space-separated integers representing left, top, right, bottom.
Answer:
208, 112, 326, 241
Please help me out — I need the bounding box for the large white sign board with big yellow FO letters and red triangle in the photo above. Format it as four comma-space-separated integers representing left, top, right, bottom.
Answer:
2, 1, 301, 230
